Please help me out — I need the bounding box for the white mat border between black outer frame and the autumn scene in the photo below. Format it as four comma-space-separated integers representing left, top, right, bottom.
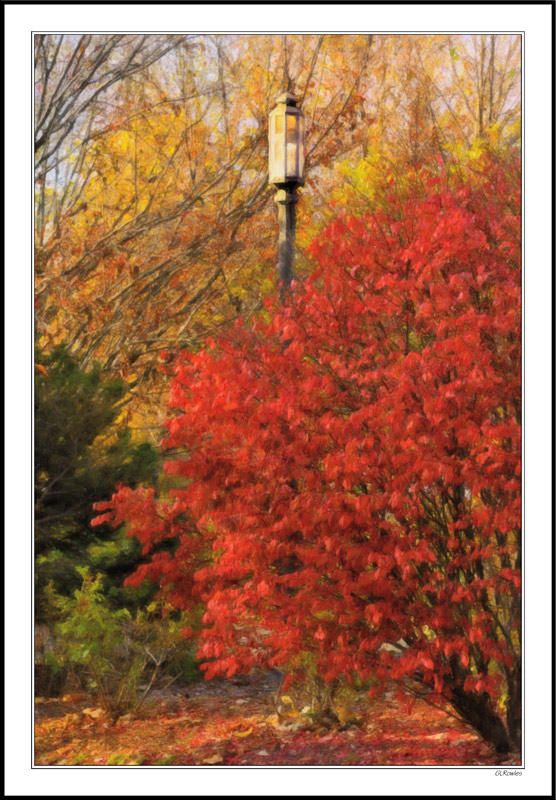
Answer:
5, 2, 554, 797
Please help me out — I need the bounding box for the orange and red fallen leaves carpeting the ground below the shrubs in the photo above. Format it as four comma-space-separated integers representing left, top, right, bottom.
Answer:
35, 681, 519, 767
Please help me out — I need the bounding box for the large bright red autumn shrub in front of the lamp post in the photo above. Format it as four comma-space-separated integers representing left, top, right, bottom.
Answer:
95, 153, 521, 750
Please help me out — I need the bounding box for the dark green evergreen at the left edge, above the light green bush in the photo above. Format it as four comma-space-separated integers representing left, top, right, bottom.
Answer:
35, 346, 159, 619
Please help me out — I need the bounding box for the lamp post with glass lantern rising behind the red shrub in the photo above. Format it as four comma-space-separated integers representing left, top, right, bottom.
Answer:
268, 92, 305, 299
